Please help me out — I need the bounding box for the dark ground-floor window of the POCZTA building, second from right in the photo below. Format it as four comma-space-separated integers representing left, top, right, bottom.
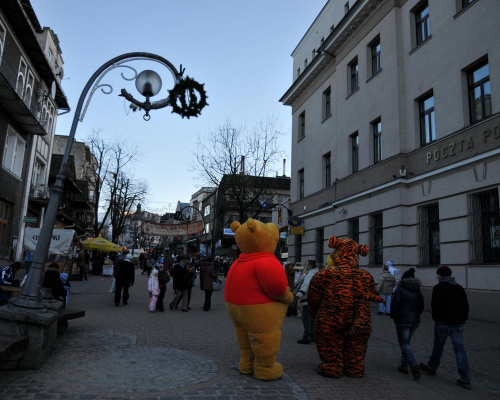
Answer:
419, 203, 441, 265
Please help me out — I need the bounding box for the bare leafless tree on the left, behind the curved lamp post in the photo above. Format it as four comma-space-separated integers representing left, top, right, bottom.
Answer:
87, 131, 148, 241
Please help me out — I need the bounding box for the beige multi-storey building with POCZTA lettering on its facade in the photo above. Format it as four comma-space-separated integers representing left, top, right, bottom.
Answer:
280, 0, 500, 321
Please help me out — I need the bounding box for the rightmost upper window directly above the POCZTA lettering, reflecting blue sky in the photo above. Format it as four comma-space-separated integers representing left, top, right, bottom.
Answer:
467, 60, 491, 123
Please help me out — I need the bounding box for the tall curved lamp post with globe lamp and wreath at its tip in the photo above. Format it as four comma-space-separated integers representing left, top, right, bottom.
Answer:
13, 52, 208, 311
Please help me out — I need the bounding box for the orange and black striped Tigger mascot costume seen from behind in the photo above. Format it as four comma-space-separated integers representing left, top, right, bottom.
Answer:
307, 236, 384, 378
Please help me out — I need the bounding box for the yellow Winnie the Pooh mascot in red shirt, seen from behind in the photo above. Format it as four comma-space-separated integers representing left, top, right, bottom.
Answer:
224, 219, 293, 381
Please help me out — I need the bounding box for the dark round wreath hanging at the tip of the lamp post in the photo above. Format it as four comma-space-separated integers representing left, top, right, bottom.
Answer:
168, 76, 208, 119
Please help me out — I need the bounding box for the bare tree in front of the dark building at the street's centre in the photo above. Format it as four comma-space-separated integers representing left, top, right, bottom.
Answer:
192, 117, 284, 245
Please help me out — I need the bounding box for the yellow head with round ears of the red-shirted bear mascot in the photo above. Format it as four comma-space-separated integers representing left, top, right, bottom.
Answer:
231, 218, 280, 254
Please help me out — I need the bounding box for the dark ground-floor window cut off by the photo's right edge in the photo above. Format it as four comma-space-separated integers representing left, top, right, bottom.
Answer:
469, 189, 500, 264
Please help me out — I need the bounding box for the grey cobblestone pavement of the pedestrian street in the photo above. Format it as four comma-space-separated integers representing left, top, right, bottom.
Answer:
0, 271, 500, 400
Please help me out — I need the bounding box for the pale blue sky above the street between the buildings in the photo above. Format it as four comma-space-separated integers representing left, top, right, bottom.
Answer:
31, 0, 326, 213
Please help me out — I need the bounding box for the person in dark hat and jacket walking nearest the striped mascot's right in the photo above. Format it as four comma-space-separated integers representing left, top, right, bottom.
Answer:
390, 268, 424, 380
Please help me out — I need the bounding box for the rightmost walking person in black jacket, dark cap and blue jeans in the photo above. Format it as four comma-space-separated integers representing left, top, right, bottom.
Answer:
420, 265, 471, 389
